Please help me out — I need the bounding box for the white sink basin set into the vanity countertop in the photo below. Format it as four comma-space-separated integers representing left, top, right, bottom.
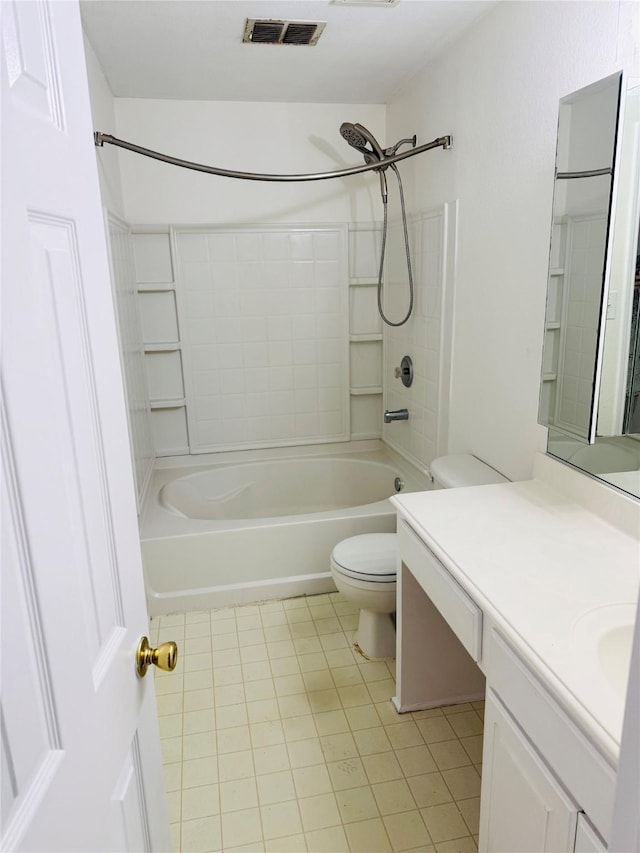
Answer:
573, 602, 636, 699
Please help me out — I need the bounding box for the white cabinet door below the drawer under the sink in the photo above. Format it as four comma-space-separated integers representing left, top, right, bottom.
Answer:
479, 690, 578, 853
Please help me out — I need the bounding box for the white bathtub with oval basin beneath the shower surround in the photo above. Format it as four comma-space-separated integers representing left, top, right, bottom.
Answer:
141, 448, 429, 616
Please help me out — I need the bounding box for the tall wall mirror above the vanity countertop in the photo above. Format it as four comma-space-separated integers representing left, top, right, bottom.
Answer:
538, 74, 640, 496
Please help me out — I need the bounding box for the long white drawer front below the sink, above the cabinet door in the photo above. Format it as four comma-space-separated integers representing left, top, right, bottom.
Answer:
484, 630, 616, 838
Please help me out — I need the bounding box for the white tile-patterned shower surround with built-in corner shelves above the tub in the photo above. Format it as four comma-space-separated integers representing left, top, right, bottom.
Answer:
110, 205, 455, 506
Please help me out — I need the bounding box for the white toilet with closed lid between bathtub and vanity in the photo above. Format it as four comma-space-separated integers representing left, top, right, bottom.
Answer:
330, 454, 508, 658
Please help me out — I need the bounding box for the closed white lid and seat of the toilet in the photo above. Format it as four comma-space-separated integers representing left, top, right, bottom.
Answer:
331, 533, 398, 583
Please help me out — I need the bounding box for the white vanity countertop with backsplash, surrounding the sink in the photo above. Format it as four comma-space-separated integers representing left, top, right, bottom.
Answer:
391, 456, 640, 764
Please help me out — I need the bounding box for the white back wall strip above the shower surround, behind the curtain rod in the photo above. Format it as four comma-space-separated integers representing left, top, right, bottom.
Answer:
115, 98, 385, 225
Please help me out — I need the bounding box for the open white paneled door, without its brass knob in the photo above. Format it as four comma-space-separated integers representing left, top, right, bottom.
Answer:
0, 0, 168, 853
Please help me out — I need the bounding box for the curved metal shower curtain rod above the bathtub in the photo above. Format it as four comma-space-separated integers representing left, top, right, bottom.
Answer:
93, 131, 452, 181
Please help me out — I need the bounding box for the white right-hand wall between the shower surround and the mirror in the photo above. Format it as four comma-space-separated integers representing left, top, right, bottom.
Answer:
386, 2, 638, 479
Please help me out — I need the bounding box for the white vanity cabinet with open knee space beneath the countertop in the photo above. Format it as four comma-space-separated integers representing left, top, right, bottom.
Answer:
393, 517, 615, 853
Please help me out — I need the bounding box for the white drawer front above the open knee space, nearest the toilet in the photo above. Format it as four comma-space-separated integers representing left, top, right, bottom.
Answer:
398, 520, 482, 662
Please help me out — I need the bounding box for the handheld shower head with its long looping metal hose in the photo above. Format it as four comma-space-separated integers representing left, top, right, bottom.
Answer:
340, 121, 420, 326
